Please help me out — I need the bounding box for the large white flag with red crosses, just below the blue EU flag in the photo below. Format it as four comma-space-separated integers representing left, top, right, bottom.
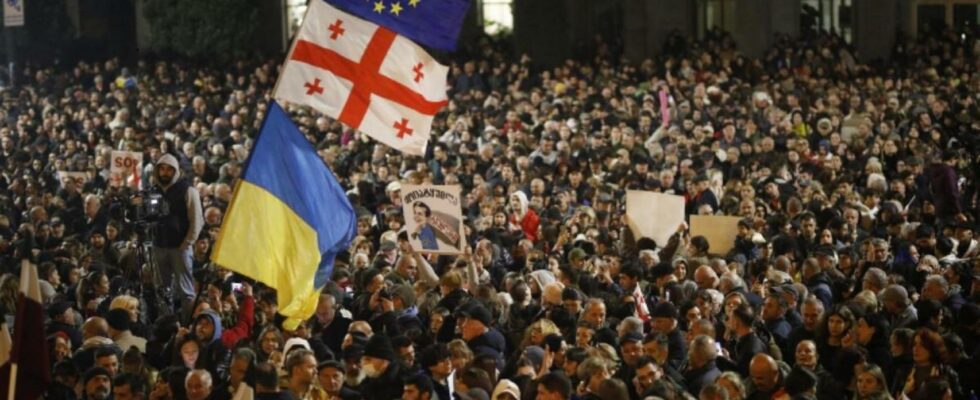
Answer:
274, 1, 449, 155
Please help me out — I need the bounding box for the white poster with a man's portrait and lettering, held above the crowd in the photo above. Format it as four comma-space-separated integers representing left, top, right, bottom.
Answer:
402, 185, 465, 254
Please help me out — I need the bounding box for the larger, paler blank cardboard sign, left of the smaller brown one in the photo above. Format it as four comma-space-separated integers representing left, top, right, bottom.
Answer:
626, 190, 684, 247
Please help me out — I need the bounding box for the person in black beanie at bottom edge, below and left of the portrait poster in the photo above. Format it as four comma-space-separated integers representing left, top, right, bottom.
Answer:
361, 335, 410, 399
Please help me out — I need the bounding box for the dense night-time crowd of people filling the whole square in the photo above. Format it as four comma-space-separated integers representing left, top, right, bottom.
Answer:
0, 20, 980, 400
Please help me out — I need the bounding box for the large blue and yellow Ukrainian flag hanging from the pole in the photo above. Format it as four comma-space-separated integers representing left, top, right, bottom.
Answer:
211, 101, 357, 328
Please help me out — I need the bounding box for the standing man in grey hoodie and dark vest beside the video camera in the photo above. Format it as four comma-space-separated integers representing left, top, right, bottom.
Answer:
153, 154, 204, 312
